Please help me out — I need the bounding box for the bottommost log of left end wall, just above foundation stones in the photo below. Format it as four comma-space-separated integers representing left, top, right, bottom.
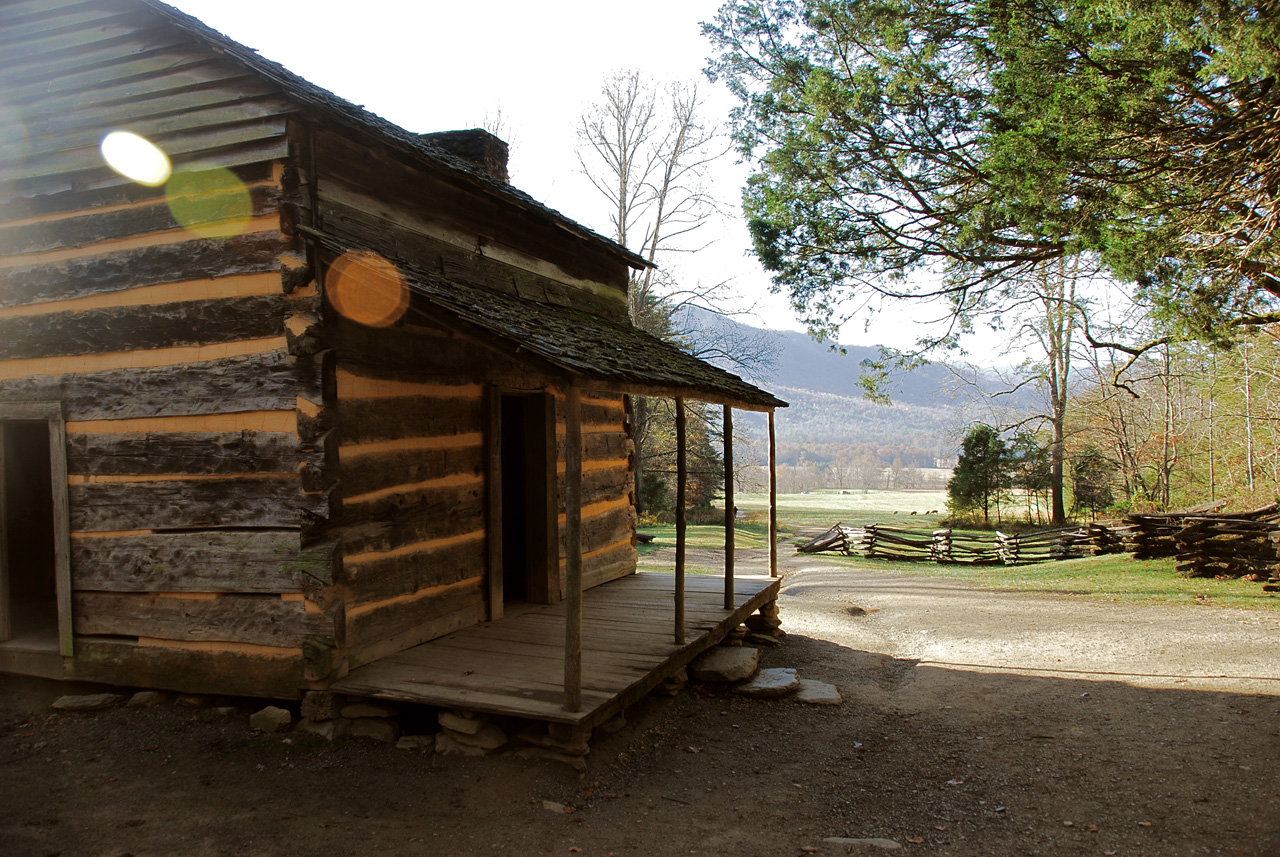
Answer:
67, 640, 305, 700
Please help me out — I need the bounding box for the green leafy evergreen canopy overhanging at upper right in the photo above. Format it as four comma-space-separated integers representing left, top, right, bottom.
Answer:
705, 0, 1280, 344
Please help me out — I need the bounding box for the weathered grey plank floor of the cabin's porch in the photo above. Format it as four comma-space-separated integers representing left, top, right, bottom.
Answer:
333, 572, 780, 727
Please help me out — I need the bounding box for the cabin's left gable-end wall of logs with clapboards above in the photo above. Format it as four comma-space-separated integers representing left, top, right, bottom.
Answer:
0, 0, 330, 696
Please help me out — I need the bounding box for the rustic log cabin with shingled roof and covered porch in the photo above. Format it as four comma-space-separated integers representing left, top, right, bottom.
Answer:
0, 0, 785, 720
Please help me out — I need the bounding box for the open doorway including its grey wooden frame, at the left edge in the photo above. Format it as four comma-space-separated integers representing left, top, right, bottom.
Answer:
0, 405, 70, 655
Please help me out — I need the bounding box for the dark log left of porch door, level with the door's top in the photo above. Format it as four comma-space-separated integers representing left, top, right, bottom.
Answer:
337, 397, 484, 445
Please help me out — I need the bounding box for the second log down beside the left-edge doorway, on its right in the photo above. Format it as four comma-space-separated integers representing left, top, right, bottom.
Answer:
68, 476, 330, 532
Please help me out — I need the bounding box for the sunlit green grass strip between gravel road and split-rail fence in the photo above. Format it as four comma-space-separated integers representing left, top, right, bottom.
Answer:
808, 554, 1280, 610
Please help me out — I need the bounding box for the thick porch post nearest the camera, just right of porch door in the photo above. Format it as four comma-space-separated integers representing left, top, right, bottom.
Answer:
564, 381, 582, 711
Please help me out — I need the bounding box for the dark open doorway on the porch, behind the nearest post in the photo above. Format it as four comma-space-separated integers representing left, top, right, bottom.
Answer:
499, 394, 559, 604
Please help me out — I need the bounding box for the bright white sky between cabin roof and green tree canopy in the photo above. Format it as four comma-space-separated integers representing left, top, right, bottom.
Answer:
169, 0, 988, 355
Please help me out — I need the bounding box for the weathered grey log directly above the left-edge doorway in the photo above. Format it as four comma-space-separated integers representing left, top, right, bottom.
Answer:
0, 348, 323, 420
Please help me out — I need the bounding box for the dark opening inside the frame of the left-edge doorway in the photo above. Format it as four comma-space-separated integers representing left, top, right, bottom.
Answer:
0, 421, 58, 640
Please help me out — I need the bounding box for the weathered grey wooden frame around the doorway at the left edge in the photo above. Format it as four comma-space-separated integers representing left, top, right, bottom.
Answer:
0, 402, 74, 657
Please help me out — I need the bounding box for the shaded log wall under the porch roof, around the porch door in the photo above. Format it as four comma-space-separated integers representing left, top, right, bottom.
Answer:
326, 312, 636, 666
